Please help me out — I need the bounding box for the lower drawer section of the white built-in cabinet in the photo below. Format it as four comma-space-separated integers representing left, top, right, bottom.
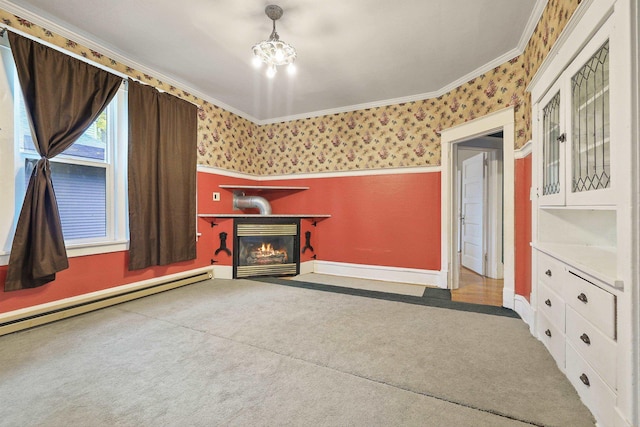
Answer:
534, 251, 619, 426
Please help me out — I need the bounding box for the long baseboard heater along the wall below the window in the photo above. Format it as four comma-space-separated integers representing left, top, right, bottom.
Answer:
0, 267, 213, 336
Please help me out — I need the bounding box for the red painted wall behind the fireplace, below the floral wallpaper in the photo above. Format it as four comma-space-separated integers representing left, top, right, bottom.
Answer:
198, 172, 440, 270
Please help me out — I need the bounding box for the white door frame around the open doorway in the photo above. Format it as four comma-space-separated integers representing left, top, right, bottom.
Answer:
440, 107, 515, 309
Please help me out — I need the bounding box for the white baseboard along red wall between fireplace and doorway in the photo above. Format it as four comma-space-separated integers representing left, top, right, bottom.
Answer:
314, 261, 447, 289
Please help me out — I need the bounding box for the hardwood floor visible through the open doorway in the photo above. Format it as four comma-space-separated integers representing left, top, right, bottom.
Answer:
451, 267, 504, 307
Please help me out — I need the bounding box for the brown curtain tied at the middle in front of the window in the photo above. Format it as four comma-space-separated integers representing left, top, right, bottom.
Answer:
4, 32, 122, 291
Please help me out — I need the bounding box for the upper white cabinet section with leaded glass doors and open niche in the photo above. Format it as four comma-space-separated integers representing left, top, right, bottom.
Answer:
534, 18, 623, 286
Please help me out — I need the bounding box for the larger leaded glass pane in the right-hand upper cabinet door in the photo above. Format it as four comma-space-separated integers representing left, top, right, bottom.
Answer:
571, 42, 611, 193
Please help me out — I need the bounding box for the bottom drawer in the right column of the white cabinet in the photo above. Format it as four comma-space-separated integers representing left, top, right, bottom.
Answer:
566, 342, 616, 426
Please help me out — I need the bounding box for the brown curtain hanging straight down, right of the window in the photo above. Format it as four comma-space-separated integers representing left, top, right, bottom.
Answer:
129, 80, 197, 270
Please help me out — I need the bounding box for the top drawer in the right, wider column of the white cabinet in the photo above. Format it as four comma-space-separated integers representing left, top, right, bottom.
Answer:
564, 270, 616, 339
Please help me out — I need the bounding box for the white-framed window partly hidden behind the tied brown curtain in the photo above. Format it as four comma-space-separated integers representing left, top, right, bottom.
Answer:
0, 39, 127, 265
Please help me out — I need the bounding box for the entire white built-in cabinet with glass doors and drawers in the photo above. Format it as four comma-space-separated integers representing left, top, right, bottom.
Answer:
529, 0, 640, 427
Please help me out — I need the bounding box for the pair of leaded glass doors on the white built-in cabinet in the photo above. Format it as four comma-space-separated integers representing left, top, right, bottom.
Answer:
538, 18, 620, 206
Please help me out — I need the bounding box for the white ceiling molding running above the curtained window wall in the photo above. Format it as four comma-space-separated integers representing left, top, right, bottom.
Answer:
0, 0, 259, 123
